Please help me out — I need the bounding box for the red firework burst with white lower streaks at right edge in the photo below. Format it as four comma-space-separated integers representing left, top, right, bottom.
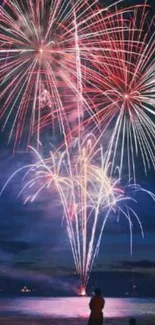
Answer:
85, 6, 155, 179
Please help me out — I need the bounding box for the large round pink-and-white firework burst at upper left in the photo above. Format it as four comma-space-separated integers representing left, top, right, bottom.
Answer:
0, 0, 138, 147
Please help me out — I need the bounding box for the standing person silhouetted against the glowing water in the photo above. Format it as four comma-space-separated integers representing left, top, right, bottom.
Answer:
88, 289, 105, 325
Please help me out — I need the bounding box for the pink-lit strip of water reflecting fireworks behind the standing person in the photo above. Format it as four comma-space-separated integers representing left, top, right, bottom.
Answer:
0, 297, 155, 318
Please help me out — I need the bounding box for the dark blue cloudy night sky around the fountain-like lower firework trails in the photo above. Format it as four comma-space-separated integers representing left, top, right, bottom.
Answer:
0, 0, 155, 296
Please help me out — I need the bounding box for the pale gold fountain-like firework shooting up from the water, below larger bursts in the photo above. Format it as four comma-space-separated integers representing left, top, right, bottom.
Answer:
1, 135, 155, 288
